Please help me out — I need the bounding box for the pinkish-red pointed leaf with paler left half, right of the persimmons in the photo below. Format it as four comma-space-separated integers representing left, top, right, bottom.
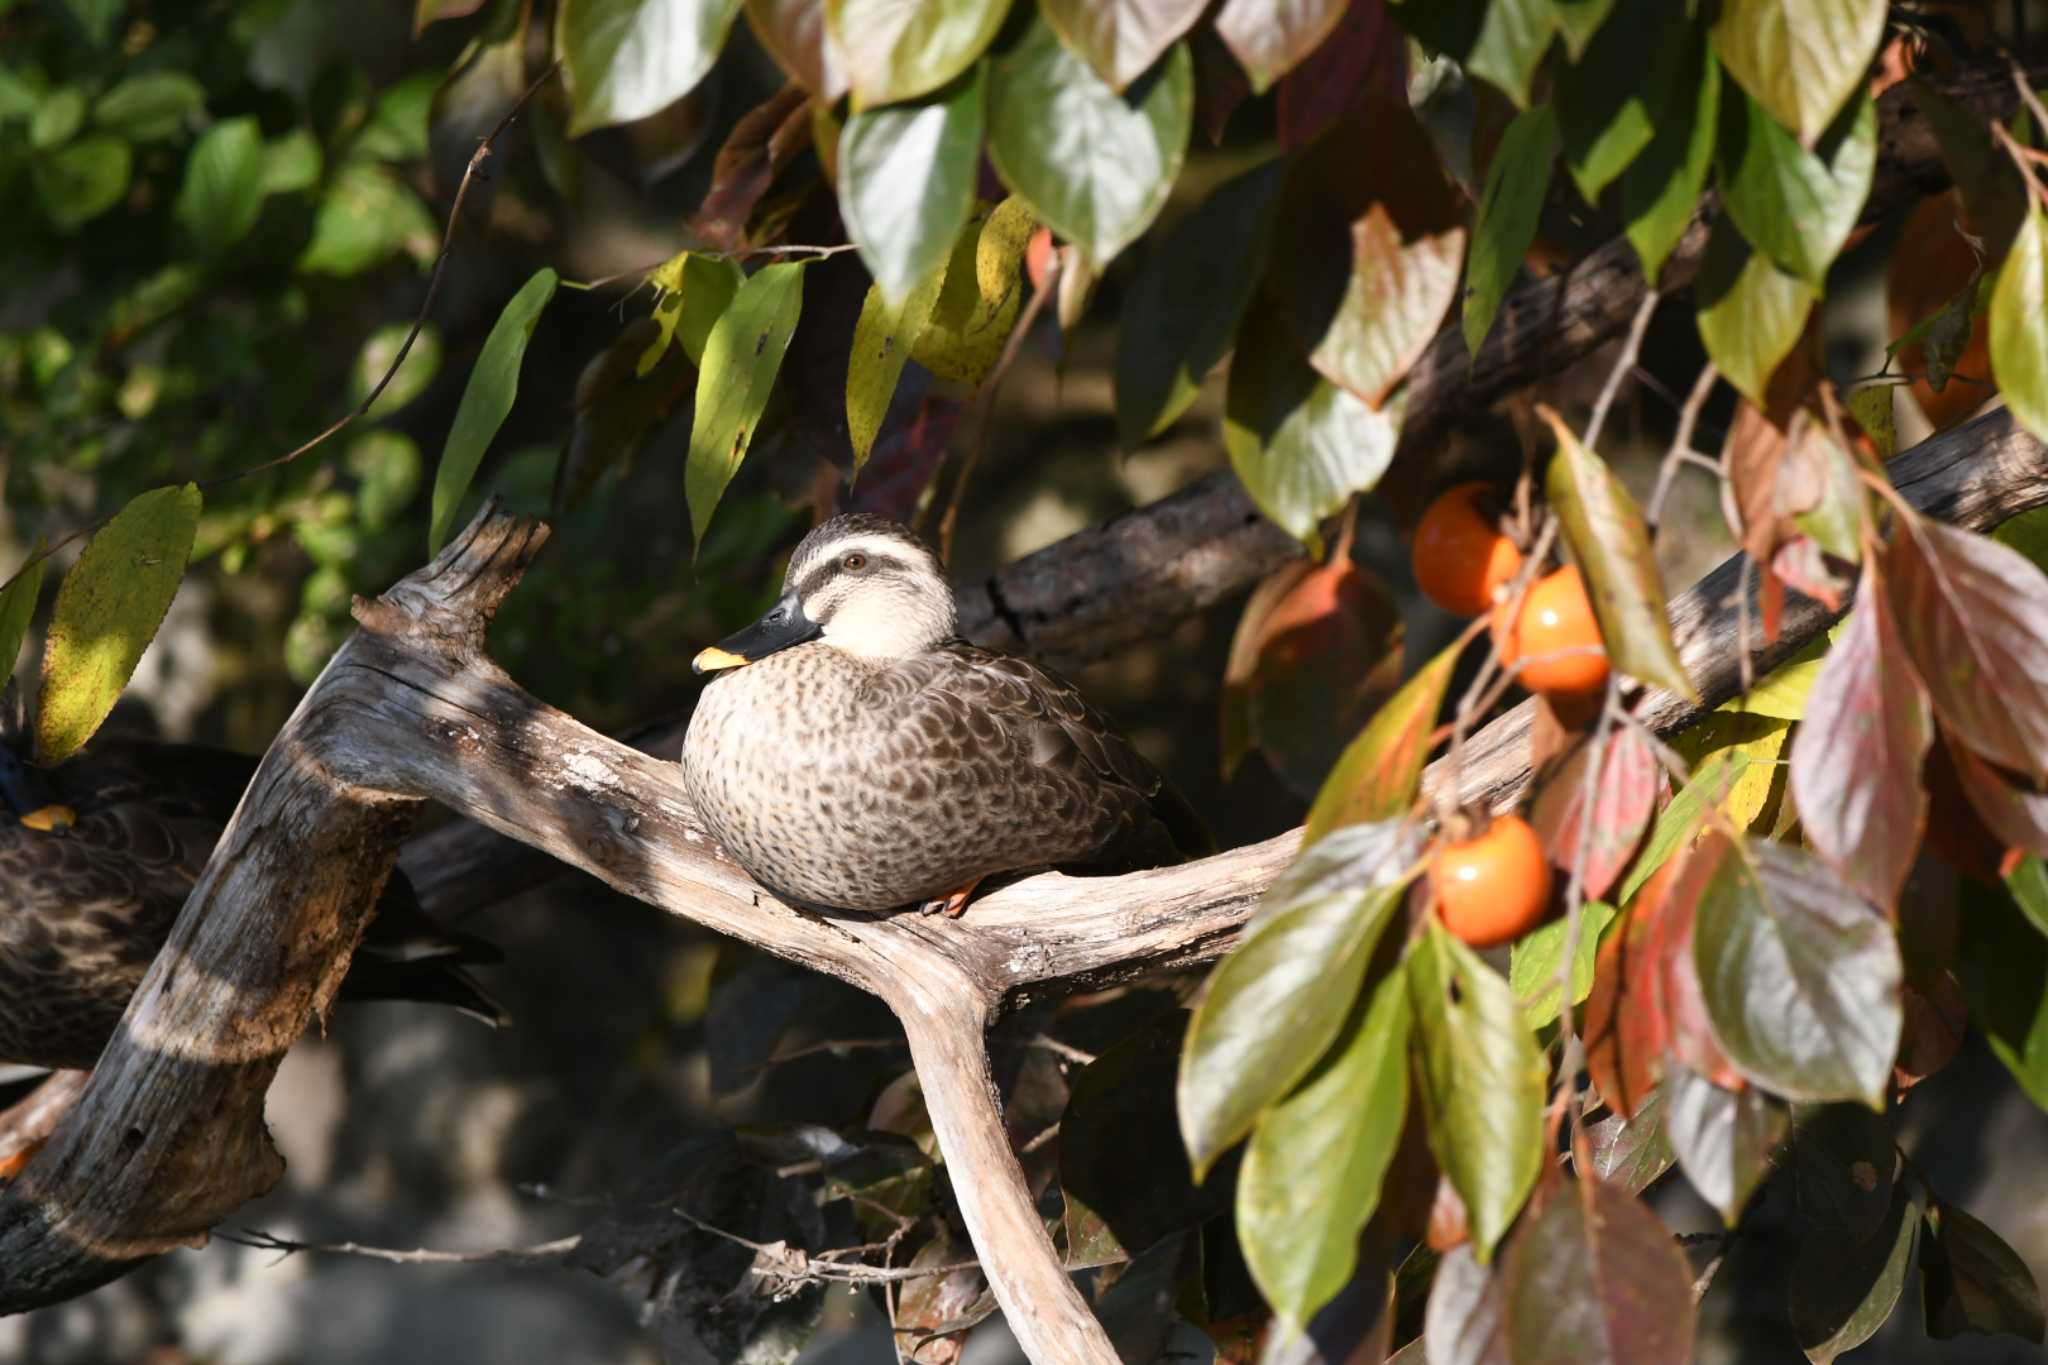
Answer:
1790, 565, 1933, 913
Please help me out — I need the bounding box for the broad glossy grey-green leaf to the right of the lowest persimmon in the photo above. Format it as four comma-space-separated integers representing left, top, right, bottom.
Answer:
1671, 831, 1903, 1105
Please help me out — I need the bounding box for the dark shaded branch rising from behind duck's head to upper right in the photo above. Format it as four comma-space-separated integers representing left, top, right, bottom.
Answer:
961, 57, 2048, 667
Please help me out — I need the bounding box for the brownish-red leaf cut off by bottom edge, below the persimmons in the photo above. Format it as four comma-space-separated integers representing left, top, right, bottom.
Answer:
1501, 1175, 1696, 1365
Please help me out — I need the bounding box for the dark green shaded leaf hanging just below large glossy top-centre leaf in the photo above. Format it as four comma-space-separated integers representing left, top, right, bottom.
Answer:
1116, 160, 1286, 450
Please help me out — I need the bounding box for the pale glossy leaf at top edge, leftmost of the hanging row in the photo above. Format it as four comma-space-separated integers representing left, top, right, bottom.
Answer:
555, 0, 739, 137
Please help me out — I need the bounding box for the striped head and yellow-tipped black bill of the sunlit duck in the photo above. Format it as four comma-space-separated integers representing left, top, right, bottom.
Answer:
690, 512, 956, 673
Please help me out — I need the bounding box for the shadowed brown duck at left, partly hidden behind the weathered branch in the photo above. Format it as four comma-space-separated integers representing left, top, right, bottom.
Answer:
0, 681, 508, 1070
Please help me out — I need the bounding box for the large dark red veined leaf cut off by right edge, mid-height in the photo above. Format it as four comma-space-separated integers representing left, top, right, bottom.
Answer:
1886, 516, 2048, 780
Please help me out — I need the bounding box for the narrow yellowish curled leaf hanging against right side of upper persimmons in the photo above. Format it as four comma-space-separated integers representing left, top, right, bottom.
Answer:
1538, 407, 1700, 698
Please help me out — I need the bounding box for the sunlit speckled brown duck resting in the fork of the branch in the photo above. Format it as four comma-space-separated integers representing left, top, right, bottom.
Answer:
682, 514, 1208, 917
